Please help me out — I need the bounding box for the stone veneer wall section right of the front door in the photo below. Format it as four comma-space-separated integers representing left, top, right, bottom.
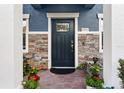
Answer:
78, 34, 103, 64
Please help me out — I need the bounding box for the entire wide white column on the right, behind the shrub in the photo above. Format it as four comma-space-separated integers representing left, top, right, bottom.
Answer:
103, 5, 124, 88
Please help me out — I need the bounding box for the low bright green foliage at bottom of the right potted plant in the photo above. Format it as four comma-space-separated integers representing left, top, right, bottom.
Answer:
86, 75, 104, 89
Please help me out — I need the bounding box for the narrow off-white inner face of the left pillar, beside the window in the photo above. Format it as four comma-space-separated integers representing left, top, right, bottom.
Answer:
13, 4, 23, 88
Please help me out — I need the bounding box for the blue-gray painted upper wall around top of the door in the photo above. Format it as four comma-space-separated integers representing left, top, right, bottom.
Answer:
23, 4, 103, 31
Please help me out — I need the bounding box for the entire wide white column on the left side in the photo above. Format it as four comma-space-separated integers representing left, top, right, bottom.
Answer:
0, 5, 23, 88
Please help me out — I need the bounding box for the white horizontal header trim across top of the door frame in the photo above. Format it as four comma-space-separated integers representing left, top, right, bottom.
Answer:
47, 13, 79, 18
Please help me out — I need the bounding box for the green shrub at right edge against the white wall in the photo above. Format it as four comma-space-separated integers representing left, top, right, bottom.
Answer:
118, 59, 124, 88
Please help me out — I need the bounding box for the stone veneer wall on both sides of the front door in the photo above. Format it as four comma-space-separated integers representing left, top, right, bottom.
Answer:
24, 34, 103, 65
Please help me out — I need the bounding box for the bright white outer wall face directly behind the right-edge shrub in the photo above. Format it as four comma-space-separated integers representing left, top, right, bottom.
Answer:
112, 5, 124, 88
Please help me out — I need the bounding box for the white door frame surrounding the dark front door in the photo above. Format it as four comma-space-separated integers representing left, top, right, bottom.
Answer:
47, 13, 79, 69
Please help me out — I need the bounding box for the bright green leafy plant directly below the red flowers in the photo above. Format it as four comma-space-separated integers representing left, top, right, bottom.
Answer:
22, 80, 38, 89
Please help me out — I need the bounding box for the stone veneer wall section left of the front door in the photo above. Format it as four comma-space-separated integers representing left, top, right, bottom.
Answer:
24, 34, 48, 66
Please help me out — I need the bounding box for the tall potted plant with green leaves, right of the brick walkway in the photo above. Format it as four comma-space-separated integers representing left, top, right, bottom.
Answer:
86, 58, 104, 89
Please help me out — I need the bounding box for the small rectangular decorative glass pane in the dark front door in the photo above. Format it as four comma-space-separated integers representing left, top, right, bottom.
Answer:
56, 23, 69, 32
